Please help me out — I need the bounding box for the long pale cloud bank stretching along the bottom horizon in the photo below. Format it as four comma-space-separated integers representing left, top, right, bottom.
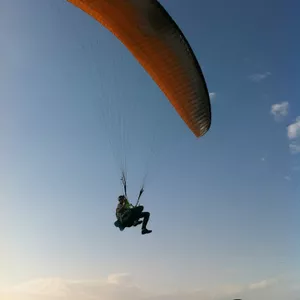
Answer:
0, 273, 291, 300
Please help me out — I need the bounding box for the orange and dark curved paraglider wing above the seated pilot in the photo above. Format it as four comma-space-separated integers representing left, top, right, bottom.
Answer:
67, 0, 211, 137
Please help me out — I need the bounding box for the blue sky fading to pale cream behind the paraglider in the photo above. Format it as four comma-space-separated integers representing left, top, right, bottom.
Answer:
0, 0, 300, 300
